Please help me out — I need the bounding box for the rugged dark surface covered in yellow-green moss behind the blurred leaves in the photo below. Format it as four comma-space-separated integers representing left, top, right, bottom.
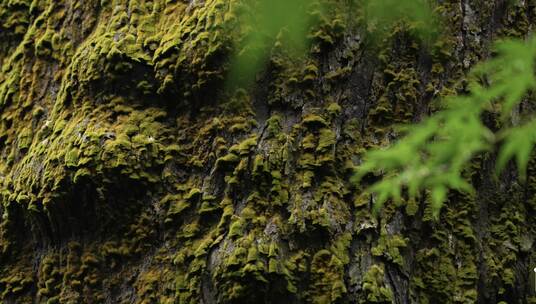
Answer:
0, 0, 536, 304
